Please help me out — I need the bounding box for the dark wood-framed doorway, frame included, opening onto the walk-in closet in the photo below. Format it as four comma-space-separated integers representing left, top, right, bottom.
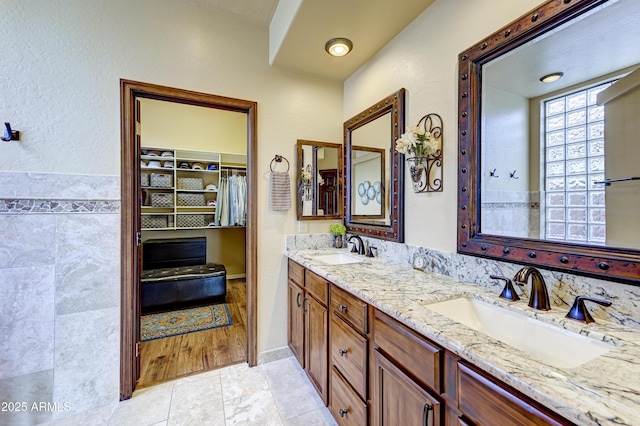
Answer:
121, 80, 257, 399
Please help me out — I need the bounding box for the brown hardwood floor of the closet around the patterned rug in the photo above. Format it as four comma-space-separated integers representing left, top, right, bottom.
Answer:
136, 278, 247, 389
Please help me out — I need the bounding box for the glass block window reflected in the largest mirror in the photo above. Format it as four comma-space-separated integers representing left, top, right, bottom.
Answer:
543, 82, 613, 244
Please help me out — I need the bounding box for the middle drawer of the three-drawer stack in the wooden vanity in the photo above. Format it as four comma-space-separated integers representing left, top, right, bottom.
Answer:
331, 313, 367, 400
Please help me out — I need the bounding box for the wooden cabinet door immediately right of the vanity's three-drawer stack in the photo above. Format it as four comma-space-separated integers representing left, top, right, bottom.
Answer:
372, 351, 442, 426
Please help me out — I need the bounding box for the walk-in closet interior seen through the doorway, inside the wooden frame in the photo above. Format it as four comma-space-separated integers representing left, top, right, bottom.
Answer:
137, 98, 247, 388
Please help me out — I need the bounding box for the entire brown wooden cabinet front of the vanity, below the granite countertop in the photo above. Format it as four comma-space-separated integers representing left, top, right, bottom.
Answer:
288, 260, 573, 426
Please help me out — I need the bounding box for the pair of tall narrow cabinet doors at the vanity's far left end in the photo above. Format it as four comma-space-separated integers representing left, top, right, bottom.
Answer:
287, 260, 329, 404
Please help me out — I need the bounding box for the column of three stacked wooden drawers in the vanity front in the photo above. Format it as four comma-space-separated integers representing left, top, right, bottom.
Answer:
329, 285, 371, 426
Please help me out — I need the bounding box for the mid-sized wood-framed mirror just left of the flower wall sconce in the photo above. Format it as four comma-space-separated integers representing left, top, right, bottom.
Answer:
344, 89, 405, 242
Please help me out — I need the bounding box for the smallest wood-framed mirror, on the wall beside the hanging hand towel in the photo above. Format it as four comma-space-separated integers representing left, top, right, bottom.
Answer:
296, 140, 343, 220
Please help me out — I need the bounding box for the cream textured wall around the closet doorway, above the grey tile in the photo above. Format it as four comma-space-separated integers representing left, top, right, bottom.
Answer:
0, 0, 342, 416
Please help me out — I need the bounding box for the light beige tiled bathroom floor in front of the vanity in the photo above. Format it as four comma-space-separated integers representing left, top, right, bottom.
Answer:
37, 357, 336, 426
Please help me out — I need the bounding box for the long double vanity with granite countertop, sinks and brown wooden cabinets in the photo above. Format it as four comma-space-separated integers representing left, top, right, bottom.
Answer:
285, 249, 640, 425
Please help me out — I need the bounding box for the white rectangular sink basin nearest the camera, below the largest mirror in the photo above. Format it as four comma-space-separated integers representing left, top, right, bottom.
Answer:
424, 297, 614, 368
